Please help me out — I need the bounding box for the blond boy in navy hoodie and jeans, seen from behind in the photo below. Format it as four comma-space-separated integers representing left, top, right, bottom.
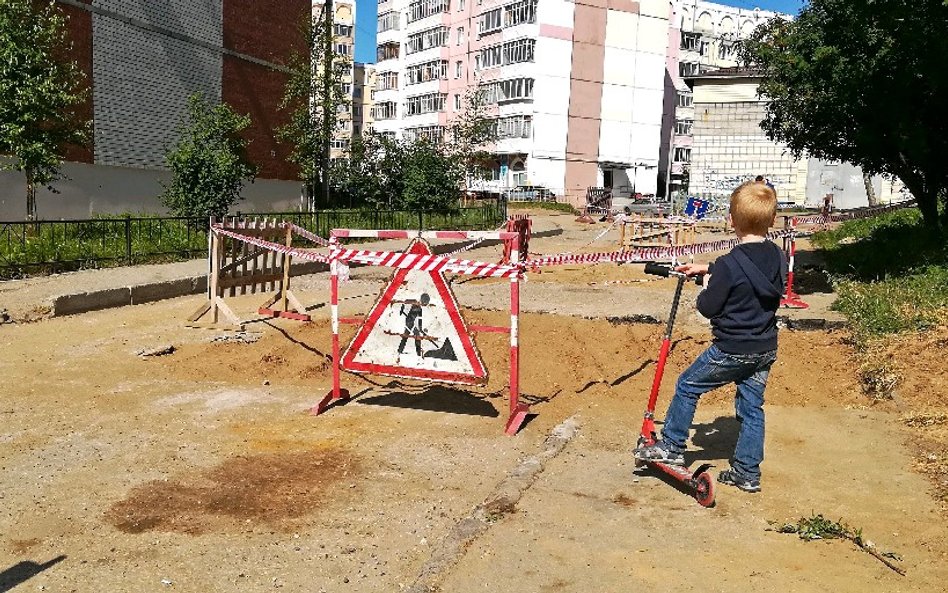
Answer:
634, 182, 787, 492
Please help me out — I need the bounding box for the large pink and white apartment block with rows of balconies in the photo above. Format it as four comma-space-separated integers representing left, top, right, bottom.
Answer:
373, 0, 671, 203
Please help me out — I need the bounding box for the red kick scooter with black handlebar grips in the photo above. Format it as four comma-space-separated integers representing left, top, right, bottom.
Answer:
635, 262, 714, 507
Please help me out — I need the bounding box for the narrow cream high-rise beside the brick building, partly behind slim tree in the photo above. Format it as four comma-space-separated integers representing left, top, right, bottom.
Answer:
313, 0, 361, 159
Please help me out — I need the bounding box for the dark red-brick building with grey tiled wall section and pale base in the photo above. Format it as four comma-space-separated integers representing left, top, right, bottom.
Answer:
0, 0, 311, 219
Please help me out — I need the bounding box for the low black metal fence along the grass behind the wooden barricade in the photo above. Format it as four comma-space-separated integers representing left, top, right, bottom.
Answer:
0, 200, 507, 279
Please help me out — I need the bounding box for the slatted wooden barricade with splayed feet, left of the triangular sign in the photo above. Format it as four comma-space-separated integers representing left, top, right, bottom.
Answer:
188, 218, 310, 328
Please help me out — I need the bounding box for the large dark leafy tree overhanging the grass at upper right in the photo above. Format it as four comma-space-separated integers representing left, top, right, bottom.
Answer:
741, 0, 948, 229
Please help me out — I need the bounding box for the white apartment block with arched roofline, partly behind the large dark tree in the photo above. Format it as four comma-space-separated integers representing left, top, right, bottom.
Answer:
658, 0, 792, 200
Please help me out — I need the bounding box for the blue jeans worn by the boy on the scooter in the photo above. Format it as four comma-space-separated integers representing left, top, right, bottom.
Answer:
662, 344, 777, 480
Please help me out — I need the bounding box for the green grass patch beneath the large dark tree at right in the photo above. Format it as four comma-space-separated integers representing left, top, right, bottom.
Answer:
812, 209, 948, 346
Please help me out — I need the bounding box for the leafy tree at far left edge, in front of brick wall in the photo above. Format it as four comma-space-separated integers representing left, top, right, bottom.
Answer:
0, 0, 89, 220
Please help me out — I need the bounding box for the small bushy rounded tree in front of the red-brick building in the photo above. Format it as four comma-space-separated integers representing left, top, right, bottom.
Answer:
161, 93, 257, 217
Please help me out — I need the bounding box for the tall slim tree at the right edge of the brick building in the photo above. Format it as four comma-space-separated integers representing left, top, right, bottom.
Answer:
277, 5, 350, 207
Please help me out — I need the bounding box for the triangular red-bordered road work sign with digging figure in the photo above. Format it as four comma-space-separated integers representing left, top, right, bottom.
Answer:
342, 239, 487, 384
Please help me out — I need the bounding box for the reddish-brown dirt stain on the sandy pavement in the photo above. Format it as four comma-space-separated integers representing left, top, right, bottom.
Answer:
106, 448, 361, 535
